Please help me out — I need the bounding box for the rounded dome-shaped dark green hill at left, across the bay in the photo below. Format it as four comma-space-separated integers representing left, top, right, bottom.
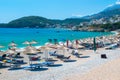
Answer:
7, 16, 52, 28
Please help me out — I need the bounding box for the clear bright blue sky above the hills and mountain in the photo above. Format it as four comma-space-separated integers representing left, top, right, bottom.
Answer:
0, 0, 117, 23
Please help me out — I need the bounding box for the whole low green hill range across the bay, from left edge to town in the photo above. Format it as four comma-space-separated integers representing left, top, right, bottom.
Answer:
0, 16, 88, 28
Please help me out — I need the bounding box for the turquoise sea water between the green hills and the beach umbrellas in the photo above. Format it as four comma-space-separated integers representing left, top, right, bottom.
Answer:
0, 28, 111, 49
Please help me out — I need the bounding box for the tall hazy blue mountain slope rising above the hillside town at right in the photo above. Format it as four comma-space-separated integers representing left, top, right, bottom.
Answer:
82, 2, 120, 19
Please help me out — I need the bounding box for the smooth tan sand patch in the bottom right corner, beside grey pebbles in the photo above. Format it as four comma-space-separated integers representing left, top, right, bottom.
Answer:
64, 49, 120, 80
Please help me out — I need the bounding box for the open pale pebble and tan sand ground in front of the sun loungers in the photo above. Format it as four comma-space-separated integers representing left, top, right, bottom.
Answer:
0, 49, 120, 80
